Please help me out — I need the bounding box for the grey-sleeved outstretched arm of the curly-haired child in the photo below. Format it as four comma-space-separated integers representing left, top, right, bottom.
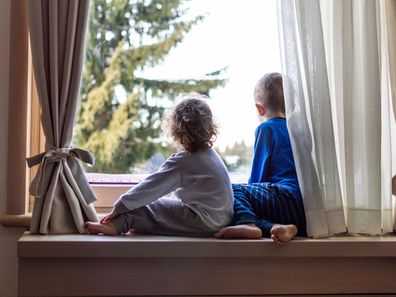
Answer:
114, 154, 181, 214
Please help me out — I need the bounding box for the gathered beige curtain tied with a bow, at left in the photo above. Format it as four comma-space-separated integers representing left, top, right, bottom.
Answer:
27, 0, 98, 234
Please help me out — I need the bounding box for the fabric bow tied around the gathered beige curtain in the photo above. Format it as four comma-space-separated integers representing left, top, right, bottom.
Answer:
26, 147, 95, 198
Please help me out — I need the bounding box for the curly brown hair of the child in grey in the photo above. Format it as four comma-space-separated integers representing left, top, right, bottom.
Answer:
164, 95, 218, 153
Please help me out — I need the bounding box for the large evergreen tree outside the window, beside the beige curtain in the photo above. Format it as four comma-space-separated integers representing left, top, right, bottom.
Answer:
74, 0, 224, 173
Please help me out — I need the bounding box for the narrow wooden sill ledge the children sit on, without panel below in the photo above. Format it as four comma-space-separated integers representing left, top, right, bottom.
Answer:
18, 232, 396, 258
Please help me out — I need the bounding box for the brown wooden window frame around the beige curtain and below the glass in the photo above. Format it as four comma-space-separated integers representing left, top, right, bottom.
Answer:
6, 0, 251, 217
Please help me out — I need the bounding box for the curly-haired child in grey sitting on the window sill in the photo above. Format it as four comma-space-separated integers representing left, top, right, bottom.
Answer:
85, 97, 233, 236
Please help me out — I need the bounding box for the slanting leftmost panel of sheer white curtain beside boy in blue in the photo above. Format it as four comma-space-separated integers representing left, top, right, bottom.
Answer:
279, 0, 346, 237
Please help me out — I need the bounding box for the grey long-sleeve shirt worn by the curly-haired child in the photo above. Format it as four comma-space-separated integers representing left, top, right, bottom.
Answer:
115, 148, 233, 231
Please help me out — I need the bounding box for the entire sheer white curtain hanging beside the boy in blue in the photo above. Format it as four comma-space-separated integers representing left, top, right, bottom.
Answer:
278, 0, 394, 237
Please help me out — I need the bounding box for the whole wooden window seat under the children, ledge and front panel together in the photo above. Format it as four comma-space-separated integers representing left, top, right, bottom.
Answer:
18, 233, 396, 297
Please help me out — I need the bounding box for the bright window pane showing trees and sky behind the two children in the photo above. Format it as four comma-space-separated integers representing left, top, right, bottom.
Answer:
74, 0, 281, 206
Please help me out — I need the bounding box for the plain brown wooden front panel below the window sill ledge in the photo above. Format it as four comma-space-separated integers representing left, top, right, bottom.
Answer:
19, 257, 396, 296
